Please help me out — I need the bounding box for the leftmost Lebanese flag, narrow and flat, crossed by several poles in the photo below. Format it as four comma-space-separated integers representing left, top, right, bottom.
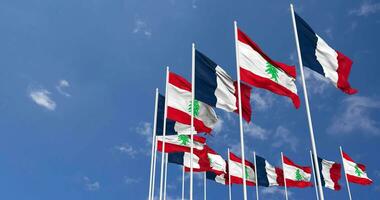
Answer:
156, 135, 206, 153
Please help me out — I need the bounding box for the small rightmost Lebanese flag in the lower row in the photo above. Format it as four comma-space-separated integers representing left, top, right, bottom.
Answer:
342, 151, 372, 185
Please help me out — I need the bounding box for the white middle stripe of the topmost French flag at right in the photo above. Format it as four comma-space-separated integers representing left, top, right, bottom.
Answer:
315, 35, 338, 86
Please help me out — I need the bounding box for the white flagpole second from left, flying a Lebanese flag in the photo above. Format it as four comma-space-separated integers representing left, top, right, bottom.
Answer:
159, 67, 169, 200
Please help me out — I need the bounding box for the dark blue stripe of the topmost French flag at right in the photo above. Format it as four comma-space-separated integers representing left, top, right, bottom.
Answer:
294, 13, 325, 76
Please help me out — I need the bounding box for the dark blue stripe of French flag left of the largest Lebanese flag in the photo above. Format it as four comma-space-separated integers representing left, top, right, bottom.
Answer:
195, 50, 218, 107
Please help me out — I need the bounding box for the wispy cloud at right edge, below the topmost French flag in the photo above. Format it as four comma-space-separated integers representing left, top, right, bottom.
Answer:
327, 95, 380, 135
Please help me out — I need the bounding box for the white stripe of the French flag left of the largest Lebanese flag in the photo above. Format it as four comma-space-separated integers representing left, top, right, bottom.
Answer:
215, 66, 237, 112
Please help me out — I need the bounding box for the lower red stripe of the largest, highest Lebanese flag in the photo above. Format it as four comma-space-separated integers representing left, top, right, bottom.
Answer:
240, 67, 301, 108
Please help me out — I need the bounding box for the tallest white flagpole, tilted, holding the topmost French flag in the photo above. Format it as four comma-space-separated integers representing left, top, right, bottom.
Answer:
290, 4, 325, 200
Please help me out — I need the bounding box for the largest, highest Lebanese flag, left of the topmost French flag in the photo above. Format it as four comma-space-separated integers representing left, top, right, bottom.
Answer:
237, 29, 300, 108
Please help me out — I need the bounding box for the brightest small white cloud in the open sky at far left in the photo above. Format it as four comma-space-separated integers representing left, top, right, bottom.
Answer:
29, 89, 57, 111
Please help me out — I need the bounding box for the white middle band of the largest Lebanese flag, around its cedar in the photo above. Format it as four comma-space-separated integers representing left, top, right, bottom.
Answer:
238, 41, 297, 94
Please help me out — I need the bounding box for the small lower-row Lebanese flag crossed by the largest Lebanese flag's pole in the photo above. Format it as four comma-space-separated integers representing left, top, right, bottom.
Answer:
228, 152, 255, 186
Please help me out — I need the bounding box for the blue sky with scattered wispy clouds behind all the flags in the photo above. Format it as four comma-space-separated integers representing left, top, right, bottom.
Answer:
0, 0, 380, 200
